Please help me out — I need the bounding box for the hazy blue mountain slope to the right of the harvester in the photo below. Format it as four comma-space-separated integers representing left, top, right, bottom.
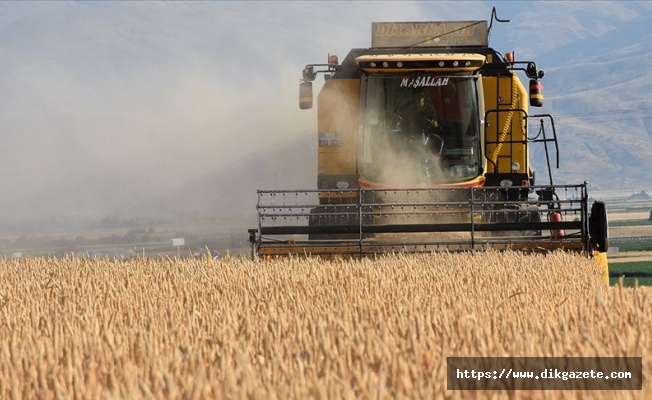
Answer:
544, 8, 652, 190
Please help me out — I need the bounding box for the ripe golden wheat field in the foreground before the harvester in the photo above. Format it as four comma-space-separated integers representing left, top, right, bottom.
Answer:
0, 252, 652, 399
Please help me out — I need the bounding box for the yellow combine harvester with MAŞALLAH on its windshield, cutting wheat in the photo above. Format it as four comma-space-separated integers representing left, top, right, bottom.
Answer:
249, 9, 608, 280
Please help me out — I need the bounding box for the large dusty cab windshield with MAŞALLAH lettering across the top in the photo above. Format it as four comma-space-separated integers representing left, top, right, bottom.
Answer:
358, 73, 481, 187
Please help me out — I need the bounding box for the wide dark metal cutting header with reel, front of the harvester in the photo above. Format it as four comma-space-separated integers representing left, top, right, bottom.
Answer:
250, 184, 589, 255
